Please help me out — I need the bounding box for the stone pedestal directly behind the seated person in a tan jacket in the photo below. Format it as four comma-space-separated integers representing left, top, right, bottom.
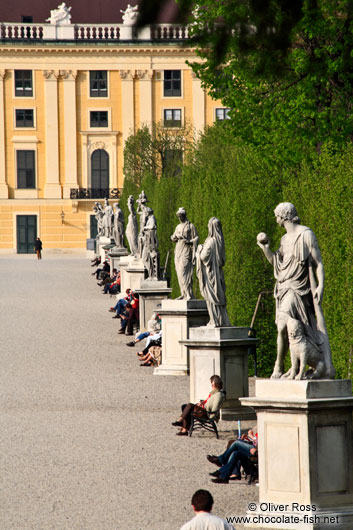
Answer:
181, 326, 258, 421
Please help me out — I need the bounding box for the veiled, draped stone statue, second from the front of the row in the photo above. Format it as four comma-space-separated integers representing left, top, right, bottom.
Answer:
196, 217, 231, 328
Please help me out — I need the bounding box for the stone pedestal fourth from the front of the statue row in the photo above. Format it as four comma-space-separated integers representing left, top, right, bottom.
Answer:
136, 280, 172, 331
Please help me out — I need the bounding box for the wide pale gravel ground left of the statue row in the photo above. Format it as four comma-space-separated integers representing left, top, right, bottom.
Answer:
0, 256, 258, 530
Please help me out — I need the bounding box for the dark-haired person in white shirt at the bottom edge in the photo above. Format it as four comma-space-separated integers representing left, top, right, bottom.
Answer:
180, 490, 235, 530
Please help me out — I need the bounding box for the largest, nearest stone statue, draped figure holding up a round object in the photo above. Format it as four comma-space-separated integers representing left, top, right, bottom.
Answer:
257, 202, 335, 379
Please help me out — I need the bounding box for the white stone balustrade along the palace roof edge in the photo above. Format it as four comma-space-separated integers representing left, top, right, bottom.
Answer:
0, 22, 188, 42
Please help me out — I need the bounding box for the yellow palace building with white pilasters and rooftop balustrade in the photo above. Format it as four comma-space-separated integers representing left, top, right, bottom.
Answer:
0, 4, 227, 253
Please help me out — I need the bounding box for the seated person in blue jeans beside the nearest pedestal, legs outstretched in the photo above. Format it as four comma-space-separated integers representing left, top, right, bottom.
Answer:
207, 429, 257, 484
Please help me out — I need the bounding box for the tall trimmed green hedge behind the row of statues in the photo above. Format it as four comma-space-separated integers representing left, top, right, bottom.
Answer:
121, 124, 353, 377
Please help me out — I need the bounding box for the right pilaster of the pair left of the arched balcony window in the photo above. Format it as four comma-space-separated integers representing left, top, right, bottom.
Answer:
60, 70, 78, 199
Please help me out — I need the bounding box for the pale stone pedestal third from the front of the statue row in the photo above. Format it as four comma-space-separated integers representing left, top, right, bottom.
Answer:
153, 300, 209, 375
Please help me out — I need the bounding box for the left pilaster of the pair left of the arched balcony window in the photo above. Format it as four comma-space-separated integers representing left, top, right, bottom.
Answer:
43, 70, 62, 199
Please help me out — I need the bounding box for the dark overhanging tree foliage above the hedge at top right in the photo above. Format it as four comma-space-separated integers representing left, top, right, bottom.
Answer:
187, 0, 353, 162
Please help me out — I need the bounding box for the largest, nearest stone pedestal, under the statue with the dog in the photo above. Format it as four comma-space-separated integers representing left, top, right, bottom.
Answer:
241, 379, 353, 530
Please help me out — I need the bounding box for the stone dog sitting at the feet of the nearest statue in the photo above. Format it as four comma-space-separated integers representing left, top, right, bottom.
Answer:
282, 317, 325, 380
